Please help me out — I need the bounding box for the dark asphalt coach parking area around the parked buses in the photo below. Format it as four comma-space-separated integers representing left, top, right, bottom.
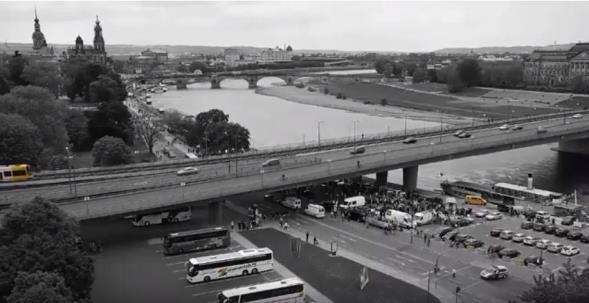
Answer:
82, 208, 312, 302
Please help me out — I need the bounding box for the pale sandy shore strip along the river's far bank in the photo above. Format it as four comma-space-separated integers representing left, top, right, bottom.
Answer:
256, 86, 472, 124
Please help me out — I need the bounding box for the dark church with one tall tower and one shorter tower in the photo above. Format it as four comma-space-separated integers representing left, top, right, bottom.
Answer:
64, 16, 107, 64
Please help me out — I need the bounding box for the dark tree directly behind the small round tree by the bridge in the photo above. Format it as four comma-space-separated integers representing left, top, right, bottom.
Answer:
88, 101, 133, 144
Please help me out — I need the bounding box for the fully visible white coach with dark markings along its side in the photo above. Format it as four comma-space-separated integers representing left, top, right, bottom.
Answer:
186, 248, 274, 283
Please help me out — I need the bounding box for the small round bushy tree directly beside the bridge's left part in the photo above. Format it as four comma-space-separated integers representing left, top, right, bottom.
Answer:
92, 136, 133, 166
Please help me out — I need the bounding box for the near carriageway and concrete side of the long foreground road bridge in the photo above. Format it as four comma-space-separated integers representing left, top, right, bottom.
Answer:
50, 113, 589, 219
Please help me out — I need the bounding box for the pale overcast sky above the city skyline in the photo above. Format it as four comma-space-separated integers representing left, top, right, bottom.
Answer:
0, 2, 589, 51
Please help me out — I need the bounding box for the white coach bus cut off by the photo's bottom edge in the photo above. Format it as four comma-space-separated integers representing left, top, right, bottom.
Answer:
217, 278, 305, 303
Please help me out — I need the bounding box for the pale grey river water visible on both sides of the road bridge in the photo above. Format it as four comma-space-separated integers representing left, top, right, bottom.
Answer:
152, 78, 589, 204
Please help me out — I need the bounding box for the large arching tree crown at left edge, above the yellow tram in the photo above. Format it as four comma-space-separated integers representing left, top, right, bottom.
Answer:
0, 86, 69, 151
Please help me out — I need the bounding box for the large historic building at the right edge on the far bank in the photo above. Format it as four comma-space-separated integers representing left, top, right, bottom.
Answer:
524, 43, 589, 87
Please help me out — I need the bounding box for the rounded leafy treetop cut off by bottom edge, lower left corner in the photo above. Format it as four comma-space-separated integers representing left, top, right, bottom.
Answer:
6, 271, 74, 303
